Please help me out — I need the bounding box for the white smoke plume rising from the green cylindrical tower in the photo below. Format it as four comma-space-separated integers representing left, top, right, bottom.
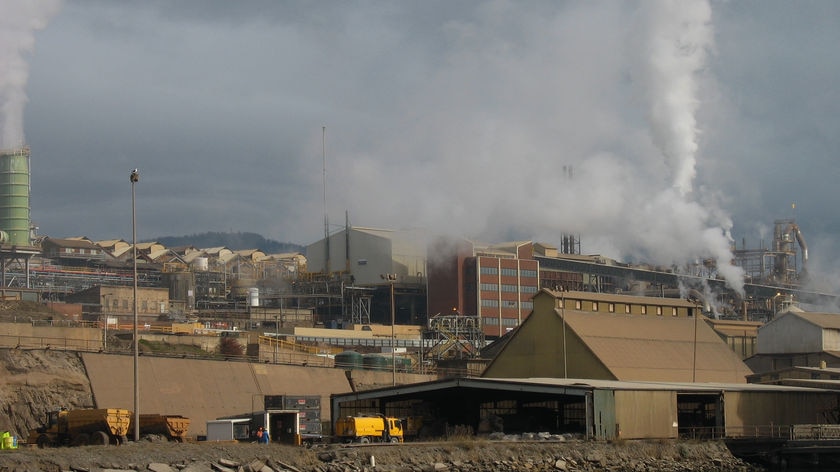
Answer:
0, 0, 61, 149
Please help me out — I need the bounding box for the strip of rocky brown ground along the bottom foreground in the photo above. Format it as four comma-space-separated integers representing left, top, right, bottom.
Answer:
0, 439, 761, 472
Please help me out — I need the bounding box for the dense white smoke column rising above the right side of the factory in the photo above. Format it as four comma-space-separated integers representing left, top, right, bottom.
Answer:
637, 0, 743, 295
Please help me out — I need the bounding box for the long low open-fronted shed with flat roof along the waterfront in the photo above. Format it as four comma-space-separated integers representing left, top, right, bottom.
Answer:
331, 378, 840, 440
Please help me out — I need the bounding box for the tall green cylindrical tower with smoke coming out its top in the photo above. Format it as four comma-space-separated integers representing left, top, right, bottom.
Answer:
0, 146, 32, 246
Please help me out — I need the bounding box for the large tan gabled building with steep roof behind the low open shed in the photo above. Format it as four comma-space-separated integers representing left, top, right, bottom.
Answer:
482, 289, 752, 383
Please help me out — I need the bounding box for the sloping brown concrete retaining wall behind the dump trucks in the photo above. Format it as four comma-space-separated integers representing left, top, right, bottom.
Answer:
82, 353, 433, 437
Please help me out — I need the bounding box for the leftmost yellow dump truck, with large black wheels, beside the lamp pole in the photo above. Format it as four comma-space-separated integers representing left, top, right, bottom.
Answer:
27, 408, 132, 447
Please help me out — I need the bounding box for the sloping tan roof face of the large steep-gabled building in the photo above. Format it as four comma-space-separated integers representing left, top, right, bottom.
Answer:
557, 310, 752, 383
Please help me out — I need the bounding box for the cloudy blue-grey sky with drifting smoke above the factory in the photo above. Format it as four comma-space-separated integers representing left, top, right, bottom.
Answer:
0, 0, 840, 294
